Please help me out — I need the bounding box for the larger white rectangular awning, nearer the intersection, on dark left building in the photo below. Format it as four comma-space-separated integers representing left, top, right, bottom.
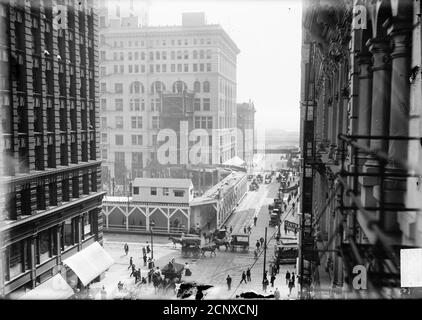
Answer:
63, 242, 114, 286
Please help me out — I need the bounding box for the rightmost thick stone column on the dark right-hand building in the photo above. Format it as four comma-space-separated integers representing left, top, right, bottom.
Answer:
383, 16, 412, 232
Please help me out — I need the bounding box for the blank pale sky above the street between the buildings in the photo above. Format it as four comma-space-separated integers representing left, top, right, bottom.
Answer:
135, 0, 301, 131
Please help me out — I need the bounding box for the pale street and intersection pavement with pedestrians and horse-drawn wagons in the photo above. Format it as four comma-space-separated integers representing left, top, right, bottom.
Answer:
91, 154, 297, 299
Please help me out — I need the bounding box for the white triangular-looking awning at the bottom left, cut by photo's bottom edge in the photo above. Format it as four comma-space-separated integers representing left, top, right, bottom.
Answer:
19, 273, 74, 300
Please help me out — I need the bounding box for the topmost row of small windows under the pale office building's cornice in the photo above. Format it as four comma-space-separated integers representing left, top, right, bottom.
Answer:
104, 49, 212, 61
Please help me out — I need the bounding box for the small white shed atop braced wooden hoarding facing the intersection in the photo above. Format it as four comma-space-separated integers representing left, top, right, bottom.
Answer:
103, 178, 193, 233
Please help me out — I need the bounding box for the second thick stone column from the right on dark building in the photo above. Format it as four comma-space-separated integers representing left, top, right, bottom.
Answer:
360, 38, 391, 206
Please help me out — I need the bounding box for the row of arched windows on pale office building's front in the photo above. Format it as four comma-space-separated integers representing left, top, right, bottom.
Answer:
100, 80, 211, 94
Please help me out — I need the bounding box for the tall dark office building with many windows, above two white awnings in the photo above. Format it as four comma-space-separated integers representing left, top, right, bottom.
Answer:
0, 0, 103, 297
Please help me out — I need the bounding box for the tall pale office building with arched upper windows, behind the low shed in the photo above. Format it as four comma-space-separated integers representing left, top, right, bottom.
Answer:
99, 10, 239, 190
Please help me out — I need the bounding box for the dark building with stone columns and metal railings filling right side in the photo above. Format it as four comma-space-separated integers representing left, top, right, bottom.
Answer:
299, 0, 422, 298
